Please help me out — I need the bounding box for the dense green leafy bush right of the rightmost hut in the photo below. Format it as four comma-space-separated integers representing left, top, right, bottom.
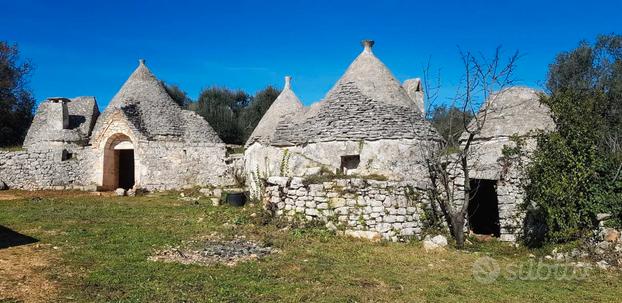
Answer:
526, 92, 622, 242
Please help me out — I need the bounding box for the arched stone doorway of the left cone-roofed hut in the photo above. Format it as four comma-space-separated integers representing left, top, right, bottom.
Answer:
102, 134, 135, 190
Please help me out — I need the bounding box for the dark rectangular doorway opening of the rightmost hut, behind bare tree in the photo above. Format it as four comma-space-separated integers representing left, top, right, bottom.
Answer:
468, 179, 501, 237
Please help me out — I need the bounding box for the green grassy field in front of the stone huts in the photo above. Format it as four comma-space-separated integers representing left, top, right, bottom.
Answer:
0, 192, 622, 302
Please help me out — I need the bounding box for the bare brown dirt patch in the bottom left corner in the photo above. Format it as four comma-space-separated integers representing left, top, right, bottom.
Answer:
0, 244, 58, 303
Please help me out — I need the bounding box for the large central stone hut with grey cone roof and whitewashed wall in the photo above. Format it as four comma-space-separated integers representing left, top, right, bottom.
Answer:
247, 41, 441, 187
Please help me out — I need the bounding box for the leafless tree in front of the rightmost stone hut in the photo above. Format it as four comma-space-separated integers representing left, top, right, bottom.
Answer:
423, 47, 519, 247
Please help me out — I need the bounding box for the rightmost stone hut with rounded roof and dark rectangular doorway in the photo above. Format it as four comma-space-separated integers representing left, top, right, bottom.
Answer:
456, 87, 554, 241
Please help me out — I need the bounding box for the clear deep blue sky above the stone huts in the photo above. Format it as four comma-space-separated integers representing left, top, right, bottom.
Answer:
0, 0, 622, 108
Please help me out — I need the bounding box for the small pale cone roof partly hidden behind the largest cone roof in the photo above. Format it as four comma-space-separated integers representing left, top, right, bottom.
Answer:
246, 76, 303, 146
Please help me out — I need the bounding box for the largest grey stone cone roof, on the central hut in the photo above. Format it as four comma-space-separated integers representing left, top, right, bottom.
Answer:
272, 41, 440, 146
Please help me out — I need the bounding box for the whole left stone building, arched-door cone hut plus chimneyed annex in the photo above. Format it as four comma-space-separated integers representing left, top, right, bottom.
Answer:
0, 60, 233, 190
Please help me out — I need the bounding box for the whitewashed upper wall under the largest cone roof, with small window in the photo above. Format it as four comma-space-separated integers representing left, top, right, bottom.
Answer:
244, 139, 436, 198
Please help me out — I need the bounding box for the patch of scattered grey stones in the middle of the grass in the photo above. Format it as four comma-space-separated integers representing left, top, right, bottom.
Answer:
149, 239, 274, 266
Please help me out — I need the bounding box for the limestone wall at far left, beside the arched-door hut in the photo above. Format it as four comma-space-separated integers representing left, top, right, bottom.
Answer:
0, 148, 94, 190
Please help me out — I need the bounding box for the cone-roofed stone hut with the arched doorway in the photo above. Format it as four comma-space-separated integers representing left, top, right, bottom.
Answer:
90, 60, 230, 190
